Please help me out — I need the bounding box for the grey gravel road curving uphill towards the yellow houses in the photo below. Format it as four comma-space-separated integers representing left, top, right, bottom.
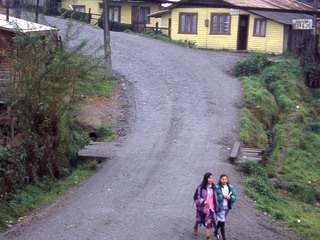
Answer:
0, 18, 301, 240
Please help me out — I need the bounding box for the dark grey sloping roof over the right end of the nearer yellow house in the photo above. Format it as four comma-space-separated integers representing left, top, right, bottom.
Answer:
249, 10, 312, 25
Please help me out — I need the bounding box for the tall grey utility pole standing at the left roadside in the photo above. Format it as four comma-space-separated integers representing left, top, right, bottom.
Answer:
103, 0, 112, 79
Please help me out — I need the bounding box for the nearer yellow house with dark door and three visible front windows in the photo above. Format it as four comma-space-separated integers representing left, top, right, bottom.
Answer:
151, 0, 312, 54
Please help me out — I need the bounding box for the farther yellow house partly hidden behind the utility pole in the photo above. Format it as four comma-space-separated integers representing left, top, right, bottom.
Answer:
61, 0, 160, 27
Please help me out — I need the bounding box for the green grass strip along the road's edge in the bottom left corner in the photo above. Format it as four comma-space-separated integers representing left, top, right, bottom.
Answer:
0, 161, 99, 229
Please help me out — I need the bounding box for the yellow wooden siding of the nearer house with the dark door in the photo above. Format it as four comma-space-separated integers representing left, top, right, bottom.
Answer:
171, 8, 285, 54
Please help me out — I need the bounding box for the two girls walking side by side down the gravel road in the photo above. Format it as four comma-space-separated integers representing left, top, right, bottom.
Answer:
193, 172, 237, 240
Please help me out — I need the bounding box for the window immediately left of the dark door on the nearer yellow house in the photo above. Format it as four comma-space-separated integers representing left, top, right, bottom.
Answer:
210, 13, 231, 34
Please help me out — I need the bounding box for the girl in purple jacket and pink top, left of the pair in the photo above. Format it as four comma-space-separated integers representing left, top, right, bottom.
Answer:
193, 172, 219, 240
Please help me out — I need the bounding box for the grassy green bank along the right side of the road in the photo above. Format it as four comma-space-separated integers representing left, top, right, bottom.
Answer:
235, 55, 320, 240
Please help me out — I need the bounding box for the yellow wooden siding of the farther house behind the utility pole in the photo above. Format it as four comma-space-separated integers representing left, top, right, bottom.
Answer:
61, 0, 160, 27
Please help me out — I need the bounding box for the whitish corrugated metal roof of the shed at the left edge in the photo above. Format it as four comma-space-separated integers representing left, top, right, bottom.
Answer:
0, 14, 59, 33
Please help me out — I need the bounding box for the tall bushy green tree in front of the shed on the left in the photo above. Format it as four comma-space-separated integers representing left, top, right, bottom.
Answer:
6, 24, 102, 182
